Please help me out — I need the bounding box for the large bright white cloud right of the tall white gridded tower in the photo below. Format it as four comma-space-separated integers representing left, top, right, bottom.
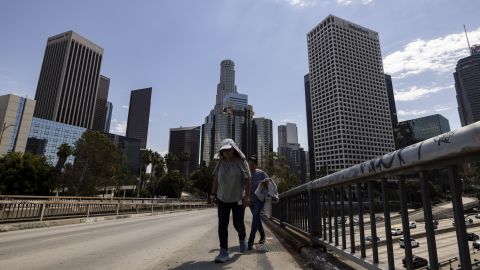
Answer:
384, 27, 480, 78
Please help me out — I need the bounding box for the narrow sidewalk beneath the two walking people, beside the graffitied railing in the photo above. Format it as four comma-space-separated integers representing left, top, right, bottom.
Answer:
159, 208, 302, 270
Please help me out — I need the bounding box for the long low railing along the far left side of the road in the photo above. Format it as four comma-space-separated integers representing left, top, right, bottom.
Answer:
0, 195, 211, 223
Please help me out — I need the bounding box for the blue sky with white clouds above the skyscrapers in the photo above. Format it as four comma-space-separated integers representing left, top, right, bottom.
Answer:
0, 0, 480, 153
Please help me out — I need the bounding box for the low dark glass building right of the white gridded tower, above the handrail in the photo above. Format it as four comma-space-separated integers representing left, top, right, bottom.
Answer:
395, 114, 450, 148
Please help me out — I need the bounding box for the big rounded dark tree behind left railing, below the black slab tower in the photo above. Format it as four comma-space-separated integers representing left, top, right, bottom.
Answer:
70, 130, 127, 195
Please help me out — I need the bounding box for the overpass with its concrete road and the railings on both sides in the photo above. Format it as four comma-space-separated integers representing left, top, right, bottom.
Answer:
0, 123, 480, 270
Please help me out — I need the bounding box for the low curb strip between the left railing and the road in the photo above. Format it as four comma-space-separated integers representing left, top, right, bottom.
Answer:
0, 208, 210, 233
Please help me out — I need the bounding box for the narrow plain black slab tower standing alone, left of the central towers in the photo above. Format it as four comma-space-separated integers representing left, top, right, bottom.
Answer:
126, 87, 152, 149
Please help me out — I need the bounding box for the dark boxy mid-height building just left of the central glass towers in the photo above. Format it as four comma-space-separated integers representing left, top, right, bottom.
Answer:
168, 126, 200, 175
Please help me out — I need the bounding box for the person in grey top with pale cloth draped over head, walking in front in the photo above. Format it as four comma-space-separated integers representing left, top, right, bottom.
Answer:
210, 139, 251, 263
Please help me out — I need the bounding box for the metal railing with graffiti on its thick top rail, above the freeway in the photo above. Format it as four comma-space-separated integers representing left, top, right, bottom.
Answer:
272, 122, 480, 270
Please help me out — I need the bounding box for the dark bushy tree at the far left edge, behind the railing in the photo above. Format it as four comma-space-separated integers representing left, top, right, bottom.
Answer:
0, 152, 55, 195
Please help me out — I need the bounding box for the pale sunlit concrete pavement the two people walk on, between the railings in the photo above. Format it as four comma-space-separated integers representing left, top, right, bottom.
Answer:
0, 209, 301, 270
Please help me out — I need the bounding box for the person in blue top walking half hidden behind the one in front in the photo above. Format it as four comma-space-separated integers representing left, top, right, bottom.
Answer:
248, 155, 268, 249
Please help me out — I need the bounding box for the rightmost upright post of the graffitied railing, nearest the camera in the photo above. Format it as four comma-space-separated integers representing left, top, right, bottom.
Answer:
448, 166, 472, 270
